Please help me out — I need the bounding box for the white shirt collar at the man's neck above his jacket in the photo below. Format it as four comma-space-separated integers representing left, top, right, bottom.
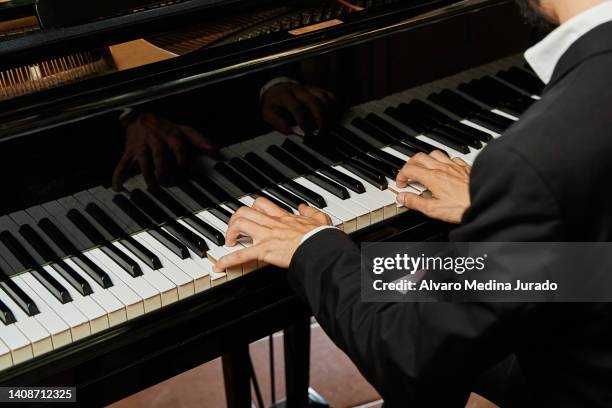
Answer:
525, 1, 612, 84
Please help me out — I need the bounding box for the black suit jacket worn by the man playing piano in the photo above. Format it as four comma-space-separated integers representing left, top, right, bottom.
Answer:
288, 23, 612, 407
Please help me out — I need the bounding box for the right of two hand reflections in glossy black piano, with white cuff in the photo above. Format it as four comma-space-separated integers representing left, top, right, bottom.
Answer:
261, 78, 338, 136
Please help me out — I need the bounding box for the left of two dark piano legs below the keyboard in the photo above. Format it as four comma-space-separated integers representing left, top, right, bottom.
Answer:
221, 344, 251, 408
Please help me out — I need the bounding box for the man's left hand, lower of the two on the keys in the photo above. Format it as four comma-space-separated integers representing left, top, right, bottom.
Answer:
214, 197, 331, 272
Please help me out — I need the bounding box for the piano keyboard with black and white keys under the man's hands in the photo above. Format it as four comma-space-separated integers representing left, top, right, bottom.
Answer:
0, 54, 543, 369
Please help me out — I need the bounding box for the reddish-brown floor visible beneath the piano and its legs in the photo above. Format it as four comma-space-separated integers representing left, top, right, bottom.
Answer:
110, 325, 495, 408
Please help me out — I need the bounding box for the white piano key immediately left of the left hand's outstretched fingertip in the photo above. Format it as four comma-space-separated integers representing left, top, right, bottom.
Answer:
133, 232, 210, 293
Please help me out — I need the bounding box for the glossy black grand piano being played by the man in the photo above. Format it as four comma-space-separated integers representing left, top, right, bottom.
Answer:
0, 0, 543, 407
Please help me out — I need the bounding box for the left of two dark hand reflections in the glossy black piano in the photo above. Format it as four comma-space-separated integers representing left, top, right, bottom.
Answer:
113, 113, 214, 191
